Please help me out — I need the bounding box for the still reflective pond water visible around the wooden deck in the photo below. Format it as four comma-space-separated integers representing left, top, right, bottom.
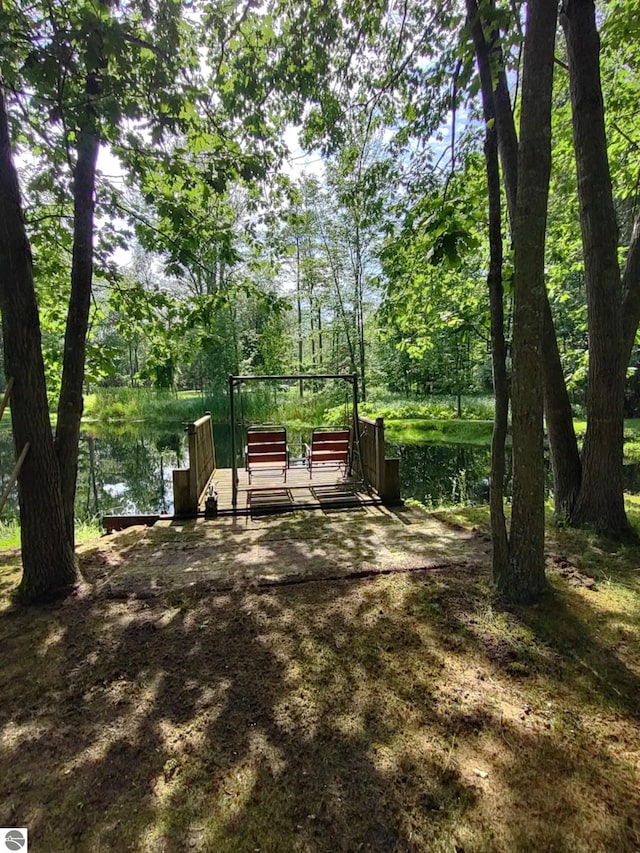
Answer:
0, 422, 640, 521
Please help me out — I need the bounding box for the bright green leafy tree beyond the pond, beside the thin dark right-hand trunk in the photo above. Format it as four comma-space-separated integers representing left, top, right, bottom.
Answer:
379, 161, 488, 410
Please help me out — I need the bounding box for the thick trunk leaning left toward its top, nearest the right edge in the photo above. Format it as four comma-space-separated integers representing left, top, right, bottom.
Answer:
561, 0, 628, 535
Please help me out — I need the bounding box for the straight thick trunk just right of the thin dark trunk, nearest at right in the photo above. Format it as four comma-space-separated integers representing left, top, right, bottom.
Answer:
504, 0, 556, 602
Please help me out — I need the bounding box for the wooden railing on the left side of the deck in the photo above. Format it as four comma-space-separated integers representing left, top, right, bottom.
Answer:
173, 413, 216, 516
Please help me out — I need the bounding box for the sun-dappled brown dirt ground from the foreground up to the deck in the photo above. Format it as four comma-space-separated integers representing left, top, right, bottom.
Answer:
0, 510, 640, 853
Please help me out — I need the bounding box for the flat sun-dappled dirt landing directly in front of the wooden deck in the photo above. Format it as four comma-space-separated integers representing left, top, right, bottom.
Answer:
79, 507, 487, 597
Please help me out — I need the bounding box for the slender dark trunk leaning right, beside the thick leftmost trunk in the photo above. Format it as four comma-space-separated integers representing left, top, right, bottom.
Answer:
55, 120, 100, 547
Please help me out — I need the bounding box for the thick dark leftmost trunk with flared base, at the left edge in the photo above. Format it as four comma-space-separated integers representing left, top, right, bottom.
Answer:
0, 92, 76, 602
